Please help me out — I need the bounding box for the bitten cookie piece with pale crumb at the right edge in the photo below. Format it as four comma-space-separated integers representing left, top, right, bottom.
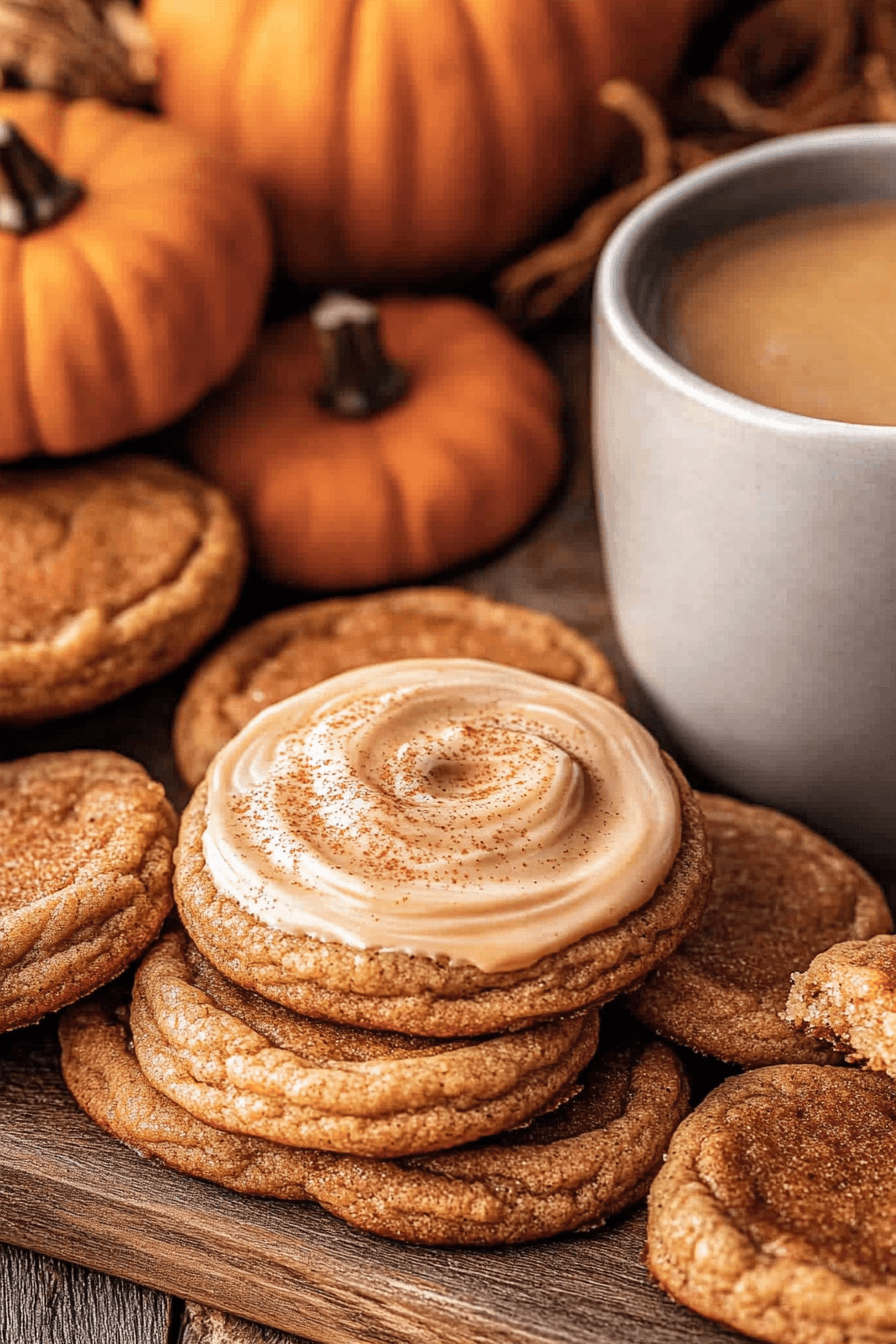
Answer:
786, 934, 896, 1078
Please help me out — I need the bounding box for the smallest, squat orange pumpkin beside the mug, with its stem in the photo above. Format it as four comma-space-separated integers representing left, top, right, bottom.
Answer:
187, 296, 563, 590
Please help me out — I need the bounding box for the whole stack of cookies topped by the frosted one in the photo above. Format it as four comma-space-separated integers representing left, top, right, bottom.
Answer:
63, 639, 709, 1245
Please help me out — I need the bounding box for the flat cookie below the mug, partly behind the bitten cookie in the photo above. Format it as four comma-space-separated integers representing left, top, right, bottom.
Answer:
626, 793, 892, 1067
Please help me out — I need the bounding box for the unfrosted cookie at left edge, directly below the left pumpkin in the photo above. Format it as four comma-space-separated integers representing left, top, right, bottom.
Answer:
0, 456, 244, 723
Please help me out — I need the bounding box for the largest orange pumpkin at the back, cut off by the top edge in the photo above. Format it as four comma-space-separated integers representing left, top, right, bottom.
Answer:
144, 0, 717, 289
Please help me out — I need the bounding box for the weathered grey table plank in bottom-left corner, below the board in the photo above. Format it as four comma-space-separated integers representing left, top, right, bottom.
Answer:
0, 1246, 173, 1344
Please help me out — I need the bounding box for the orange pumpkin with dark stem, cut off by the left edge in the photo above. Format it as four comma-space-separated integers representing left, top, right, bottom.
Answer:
0, 93, 270, 461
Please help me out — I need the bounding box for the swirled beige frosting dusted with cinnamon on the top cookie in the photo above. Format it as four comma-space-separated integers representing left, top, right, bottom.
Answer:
203, 659, 681, 972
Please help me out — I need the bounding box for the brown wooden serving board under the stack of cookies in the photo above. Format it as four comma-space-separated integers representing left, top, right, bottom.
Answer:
0, 1019, 742, 1344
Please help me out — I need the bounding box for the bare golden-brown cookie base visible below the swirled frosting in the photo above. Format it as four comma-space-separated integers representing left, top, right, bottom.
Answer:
175, 757, 712, 1036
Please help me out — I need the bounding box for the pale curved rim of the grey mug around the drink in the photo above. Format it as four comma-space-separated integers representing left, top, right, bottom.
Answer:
594, 122, 896, 444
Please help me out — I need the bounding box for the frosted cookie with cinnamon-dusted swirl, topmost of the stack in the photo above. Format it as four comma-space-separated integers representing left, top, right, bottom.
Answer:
175, 659, 711, 1036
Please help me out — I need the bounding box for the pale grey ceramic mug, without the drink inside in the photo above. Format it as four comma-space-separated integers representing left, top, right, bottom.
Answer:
594, 126, 896, 876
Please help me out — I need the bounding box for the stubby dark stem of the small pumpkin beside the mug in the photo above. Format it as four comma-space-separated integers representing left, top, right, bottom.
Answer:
312, 292, 410, 419
